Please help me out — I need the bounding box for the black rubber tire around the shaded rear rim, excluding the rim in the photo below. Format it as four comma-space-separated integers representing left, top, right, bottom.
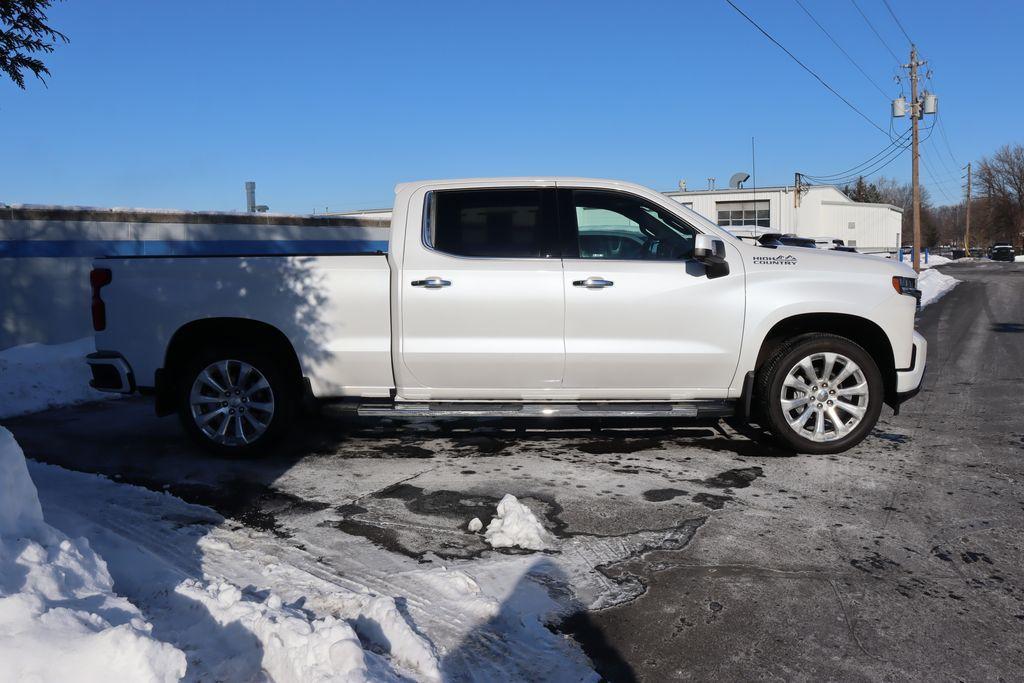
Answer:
175, 347, 298, 457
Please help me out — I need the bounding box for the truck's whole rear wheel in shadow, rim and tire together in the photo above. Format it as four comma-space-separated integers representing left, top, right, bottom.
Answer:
178, 349, 295, 456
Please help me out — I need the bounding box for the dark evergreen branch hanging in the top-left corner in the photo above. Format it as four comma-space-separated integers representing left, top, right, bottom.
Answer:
0, 0, 68, 90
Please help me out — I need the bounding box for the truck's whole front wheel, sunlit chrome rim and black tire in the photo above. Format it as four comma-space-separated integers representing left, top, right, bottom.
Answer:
758, 334, 884, 454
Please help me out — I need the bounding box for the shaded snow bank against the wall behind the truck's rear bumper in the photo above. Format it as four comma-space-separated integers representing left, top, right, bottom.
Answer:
0, 337, 114, 418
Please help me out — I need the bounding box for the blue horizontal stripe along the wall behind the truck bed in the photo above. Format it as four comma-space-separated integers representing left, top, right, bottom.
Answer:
0, 240, 388, 258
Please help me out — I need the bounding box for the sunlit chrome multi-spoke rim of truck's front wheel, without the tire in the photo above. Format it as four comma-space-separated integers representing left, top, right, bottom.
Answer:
779, 352, 869, 442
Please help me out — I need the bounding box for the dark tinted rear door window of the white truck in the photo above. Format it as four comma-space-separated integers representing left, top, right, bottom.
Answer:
423, 189, 560, 258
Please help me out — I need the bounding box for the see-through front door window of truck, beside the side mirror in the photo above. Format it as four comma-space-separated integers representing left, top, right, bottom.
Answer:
572, 189, 696, 261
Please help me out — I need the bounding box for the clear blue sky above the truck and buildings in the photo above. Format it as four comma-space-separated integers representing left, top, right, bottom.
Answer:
0, 0, 1024, 213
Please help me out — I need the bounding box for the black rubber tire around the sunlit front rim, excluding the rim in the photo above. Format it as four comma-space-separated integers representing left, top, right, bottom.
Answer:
755, 333, 885, 455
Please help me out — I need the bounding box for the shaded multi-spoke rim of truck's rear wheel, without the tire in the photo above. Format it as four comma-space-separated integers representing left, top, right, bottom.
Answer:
188, 360, 273, 445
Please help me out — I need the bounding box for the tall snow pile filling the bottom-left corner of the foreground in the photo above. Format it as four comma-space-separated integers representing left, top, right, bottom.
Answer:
0, 427, 185, 682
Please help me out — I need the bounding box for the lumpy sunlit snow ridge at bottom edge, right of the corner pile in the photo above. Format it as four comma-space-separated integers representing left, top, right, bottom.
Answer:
175, 579, 368, 683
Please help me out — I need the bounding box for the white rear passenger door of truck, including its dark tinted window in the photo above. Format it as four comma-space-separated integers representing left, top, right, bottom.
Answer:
397, 186, 565, 399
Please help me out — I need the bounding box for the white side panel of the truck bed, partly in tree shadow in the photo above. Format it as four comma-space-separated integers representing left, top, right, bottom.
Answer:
95, 254, 393, 397
